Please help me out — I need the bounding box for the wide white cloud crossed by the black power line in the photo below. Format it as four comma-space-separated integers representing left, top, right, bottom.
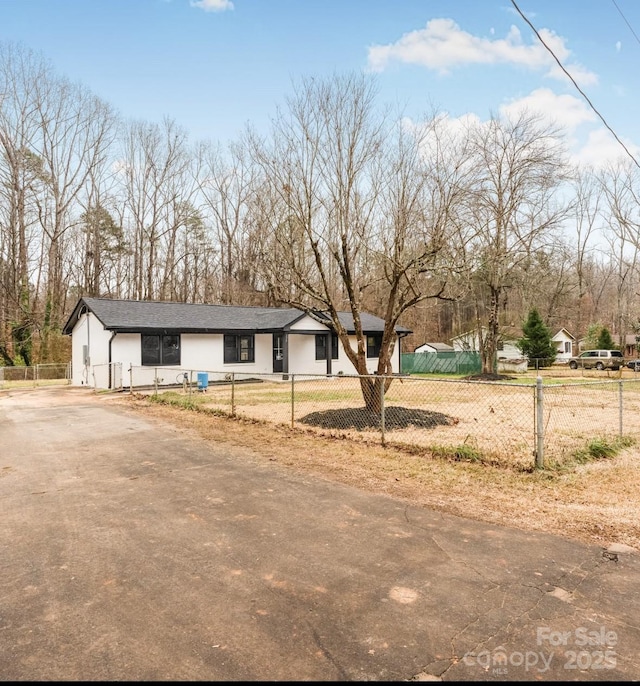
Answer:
369, 19, 597, 84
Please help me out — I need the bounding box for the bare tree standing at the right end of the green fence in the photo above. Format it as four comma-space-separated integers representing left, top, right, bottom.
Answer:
468, 113, 566, 374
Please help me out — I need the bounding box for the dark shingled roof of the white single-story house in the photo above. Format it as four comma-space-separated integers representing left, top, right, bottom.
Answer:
62, 298, 410, 334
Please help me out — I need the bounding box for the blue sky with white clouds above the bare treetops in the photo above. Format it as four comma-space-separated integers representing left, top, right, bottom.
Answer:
0, 0, 640, 167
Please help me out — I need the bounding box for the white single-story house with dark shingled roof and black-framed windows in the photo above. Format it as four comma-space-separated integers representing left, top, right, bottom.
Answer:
63, 298, 411, 388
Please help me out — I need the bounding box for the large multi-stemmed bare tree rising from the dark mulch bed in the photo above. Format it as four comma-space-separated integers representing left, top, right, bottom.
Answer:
252, 76, 472, 411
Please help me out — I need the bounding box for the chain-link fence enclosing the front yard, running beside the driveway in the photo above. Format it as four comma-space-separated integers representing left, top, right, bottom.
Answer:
129, 367, 640, 470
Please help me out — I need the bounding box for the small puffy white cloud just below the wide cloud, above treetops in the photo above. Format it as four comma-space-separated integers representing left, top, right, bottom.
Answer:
500, 88, 597, 132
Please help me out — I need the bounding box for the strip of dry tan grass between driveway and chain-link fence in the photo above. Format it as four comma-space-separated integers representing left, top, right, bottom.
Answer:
117, 395, 640, 549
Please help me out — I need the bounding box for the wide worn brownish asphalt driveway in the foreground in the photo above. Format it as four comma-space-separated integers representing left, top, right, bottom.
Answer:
0, 388, 640, 681
